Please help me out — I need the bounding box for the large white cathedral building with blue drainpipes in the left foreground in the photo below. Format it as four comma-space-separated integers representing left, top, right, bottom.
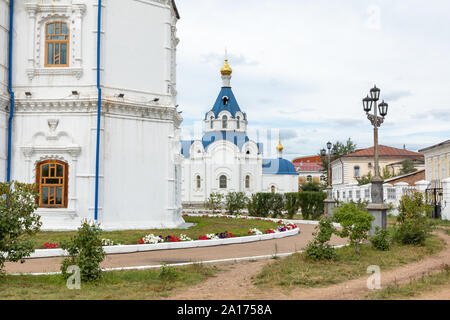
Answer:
0, 0, 184, 230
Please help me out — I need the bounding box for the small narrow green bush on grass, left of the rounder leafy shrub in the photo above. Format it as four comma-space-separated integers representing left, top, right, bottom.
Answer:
305, 218, 336, 260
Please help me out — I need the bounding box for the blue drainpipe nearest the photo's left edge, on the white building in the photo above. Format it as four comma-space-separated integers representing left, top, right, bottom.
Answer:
6, 0, 14, 182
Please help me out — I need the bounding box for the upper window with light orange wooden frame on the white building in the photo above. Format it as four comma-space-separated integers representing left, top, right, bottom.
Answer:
45, 21, 69, 67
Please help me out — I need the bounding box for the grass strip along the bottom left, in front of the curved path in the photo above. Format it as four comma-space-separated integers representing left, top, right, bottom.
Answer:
0, 264, 219, 300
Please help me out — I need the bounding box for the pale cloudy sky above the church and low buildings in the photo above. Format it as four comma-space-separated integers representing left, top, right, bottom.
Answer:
177, 0, 450, 159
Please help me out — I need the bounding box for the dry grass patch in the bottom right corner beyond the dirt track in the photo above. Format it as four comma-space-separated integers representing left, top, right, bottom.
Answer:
366, 265, 450, 300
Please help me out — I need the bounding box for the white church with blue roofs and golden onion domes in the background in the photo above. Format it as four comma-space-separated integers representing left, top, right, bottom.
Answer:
181, 60, 298, 206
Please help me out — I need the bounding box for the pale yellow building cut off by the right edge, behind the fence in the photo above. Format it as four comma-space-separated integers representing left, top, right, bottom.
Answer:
419, 140, 450, 181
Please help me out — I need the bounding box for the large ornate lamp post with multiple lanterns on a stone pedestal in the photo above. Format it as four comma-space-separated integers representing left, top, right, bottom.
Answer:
363, 86, 388, 234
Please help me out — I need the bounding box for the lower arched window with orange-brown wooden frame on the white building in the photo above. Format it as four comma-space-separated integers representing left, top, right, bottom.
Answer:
36, 160, 69, 208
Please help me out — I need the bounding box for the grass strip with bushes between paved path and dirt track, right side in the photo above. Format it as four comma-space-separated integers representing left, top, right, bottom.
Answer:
255, 236, 445, 288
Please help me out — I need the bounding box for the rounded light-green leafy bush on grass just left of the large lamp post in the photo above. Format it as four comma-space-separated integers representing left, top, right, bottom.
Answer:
333, 202, 375, 254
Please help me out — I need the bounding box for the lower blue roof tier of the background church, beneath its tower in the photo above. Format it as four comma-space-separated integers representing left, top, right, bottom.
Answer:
181, 131, 263, 158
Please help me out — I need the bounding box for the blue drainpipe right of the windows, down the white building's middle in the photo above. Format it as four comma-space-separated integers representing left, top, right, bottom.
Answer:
94, 0, 102, 221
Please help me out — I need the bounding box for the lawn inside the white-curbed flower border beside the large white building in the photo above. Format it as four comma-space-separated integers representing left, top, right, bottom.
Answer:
26, 217, 278, 249
